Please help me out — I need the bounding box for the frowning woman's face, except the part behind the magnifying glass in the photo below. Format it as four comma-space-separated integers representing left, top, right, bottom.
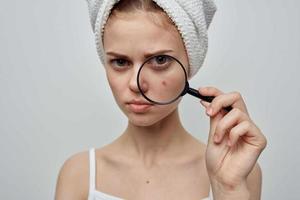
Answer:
103, 11, 188, 126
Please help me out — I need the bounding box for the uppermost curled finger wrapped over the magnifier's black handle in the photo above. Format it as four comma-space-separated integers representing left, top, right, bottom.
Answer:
208, 92, 248, 116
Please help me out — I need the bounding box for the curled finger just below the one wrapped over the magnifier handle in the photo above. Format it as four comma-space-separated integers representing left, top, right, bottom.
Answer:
214, 108, 249, 143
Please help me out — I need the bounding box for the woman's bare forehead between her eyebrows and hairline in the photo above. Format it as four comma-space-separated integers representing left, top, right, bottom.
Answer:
103, 11, 184, 55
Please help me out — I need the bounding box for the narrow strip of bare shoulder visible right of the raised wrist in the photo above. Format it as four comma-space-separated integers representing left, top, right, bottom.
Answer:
247, 163, 262, 200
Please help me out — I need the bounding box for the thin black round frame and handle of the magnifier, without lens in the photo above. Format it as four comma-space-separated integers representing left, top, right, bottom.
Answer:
137, 54, 232, 112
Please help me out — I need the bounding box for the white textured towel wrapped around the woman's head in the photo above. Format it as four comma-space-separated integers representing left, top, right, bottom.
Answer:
87, 0, 216, 78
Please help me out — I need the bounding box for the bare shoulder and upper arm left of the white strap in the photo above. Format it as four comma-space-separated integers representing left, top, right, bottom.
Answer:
55, 151, 89, 200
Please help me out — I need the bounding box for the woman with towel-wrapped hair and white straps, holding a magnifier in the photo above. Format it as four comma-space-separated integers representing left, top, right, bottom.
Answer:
55, 0, 267, 200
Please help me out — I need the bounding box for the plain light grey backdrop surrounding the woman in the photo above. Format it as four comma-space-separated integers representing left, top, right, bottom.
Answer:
0, 0, 300, 200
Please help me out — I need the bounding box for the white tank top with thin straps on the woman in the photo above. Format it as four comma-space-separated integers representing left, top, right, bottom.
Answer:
88, 148, 213, 200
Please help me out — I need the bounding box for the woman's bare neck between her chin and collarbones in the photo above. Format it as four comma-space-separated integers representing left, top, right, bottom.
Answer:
121, 109, 187, 165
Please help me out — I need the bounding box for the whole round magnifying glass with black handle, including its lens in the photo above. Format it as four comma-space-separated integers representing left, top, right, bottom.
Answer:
137, 54, 232, 112
